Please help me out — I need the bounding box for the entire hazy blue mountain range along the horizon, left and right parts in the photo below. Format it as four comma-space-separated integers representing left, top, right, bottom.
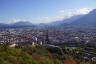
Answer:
0, 9, 96, 27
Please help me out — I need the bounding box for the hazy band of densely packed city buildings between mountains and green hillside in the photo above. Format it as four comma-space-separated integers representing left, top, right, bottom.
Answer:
0, 27, 96, 45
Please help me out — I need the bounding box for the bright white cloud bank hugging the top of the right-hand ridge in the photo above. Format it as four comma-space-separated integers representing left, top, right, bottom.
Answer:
38, 8, 91, 23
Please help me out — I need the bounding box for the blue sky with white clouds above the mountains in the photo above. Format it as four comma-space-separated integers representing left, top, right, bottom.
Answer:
0, 0, 96, 24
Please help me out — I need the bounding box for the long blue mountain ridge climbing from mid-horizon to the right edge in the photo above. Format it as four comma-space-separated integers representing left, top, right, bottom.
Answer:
48, 9, 96, 27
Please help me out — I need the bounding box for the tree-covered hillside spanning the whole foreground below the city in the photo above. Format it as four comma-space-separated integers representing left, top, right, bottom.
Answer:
0, 45, 96, 64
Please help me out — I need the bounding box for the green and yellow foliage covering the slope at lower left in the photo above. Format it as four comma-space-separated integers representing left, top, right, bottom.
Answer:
0, 45, 62, 64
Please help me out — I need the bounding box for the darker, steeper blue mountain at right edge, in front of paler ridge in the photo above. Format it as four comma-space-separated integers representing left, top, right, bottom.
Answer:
70, 9, 96, 27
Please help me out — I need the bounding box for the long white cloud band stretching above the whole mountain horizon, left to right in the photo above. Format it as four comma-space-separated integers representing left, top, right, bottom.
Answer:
0, 8, 91, 24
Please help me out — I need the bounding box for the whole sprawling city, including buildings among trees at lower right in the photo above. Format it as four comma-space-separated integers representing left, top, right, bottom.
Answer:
0, 26, 96, 61
